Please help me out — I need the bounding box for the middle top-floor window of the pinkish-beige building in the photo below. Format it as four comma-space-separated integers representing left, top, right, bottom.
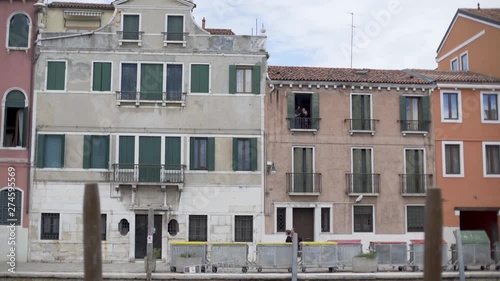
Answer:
351, 94, 373, 131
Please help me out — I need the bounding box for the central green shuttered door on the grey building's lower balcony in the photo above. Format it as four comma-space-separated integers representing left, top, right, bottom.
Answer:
139, 137, 161, 182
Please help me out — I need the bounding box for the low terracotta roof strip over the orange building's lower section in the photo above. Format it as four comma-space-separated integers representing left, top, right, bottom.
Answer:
410, 69, 500, 83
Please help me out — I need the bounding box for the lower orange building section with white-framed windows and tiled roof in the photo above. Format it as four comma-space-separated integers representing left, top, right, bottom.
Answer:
414, 70, 500, 249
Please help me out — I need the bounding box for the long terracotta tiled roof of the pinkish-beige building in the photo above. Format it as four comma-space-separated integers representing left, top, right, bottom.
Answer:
268, 66, 430, 84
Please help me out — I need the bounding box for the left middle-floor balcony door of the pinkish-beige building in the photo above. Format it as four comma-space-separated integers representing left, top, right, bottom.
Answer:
293, 147, 314, 193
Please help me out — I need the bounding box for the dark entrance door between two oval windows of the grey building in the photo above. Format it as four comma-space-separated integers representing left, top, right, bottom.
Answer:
135, 215, 162, 259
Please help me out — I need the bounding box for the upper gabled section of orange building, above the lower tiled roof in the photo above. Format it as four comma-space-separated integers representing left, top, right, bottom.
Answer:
436, 6, 500, 77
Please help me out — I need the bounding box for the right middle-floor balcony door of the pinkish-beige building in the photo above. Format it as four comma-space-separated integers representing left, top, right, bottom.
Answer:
405, 149, 425, 193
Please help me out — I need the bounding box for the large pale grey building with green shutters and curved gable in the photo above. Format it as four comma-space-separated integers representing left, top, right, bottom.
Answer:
30, 0, 267, 261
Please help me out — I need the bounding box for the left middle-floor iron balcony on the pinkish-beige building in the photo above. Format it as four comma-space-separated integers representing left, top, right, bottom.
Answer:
286, 173, 321, 196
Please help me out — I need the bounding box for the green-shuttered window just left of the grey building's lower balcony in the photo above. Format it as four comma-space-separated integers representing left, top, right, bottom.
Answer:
83, 136, 109, 169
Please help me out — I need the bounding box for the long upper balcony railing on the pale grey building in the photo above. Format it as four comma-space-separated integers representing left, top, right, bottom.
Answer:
116, 91, 186, 106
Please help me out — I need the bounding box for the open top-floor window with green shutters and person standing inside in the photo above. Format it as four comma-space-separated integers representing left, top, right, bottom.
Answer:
287, 93, 320, 130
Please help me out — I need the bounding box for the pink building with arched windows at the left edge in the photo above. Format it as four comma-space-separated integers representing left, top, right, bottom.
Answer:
0, 0, 37, 261
